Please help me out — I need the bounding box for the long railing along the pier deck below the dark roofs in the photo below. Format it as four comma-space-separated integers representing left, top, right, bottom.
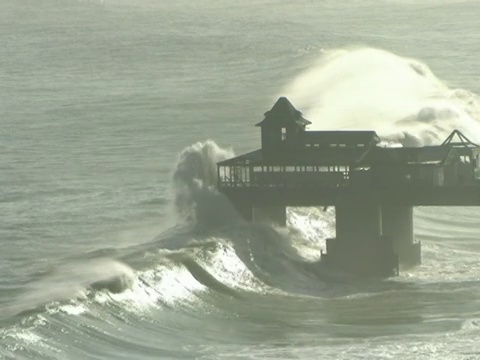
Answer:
218, 164, 480, 188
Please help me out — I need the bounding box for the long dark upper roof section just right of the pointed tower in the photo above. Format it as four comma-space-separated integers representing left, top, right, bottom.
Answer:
304, 130, 380, 145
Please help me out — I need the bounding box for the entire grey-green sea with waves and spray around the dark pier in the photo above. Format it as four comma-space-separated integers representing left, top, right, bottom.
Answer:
0, 0, 480, 359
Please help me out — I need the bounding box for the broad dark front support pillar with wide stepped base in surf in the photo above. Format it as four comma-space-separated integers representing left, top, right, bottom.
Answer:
322, 202, 398, 277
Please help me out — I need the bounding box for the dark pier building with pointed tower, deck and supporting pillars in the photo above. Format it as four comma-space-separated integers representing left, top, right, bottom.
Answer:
218, 97, 480, 276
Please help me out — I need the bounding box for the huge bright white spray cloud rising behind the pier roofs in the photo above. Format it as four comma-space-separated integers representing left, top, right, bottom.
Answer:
282, 48, 480, 146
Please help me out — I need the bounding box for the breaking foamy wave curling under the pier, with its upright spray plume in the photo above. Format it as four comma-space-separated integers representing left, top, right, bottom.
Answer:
0, 141, 338, 357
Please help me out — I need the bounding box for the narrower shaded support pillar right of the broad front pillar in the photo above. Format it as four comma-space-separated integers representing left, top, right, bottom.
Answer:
382, 206, 421, 268
